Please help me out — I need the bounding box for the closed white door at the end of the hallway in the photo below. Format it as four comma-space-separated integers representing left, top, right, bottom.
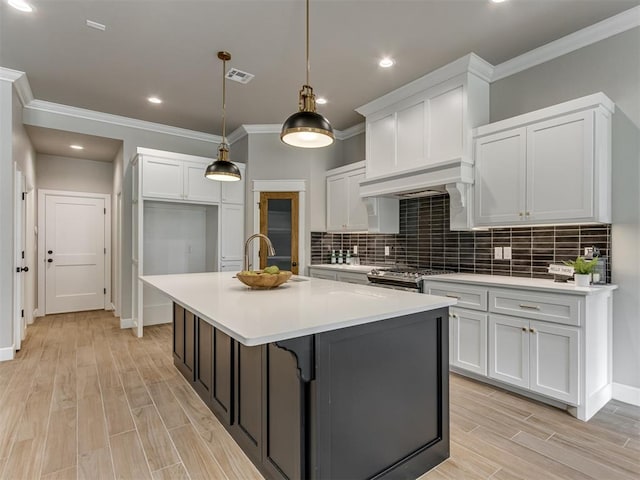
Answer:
44, 194, 106, 314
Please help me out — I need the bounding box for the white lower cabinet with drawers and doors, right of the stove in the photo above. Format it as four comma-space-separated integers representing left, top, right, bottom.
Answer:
424, 275, 615, 421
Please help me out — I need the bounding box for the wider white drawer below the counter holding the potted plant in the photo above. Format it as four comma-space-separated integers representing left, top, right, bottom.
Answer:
489, 289, 582, 325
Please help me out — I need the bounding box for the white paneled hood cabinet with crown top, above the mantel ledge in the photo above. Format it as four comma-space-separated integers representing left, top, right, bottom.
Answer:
357, 54, 492, 196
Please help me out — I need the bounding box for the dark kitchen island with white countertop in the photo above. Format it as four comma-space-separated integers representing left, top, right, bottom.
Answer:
141, 273, 455, 480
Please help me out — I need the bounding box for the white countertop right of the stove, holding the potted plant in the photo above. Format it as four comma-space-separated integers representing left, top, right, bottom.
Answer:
425, 273, 618, 295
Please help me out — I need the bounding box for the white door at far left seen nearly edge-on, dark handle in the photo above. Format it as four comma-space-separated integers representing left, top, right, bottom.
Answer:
13, 170, 28, 350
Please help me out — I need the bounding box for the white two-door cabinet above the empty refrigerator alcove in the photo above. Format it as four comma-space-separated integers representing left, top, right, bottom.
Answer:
138, 148, 221, 203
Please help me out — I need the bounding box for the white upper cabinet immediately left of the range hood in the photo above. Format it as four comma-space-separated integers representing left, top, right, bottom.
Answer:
327, 162, 368, 232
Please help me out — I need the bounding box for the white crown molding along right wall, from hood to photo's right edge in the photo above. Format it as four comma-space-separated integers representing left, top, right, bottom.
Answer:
491, 6, 640, 82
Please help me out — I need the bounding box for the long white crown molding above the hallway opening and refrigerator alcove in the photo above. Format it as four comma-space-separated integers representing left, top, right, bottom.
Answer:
24, 100, 222, 143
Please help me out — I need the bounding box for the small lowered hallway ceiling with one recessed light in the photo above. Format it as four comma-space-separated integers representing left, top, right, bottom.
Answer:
25, 125, 122, 162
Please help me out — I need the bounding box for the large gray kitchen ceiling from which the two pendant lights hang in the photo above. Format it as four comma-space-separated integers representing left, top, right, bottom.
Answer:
0, 0, 638, 141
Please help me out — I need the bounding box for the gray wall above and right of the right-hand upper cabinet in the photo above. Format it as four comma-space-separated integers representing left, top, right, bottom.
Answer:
491, 28, 640, 387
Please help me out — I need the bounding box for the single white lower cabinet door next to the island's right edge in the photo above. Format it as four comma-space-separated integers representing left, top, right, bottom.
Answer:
449, 308, 487, 375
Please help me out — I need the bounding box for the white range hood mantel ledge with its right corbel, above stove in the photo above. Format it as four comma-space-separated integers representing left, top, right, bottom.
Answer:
360, 158, 473, 230
